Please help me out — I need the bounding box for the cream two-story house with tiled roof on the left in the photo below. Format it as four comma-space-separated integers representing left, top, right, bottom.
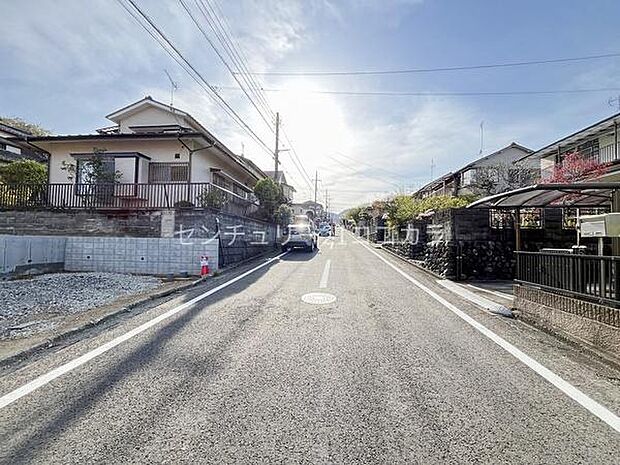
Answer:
10, 97, 266, 209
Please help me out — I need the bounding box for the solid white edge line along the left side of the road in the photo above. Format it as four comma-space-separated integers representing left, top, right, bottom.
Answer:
0, 252, 288, 409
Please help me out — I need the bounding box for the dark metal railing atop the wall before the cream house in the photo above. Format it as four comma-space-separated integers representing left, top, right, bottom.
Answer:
0, 183, 257, 213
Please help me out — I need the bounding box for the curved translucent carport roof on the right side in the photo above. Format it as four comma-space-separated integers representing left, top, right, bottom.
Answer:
467, 182, 620, 208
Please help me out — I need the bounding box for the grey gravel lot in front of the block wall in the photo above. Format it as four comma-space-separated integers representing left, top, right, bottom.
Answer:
0, 273, 161, 339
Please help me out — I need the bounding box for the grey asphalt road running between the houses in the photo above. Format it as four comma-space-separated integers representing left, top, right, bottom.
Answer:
0, 230, 620, 464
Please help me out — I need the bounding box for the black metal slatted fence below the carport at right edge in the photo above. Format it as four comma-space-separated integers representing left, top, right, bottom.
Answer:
515, 252, 620, 307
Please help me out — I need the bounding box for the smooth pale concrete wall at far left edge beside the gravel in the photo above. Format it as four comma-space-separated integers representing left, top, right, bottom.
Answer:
0, 235, 67, 277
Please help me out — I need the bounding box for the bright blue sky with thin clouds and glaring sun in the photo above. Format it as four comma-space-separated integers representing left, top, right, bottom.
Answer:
0, 0, 620, 211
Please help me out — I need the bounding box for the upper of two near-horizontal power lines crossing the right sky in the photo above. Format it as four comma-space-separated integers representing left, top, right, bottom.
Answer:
239, 53, 620, 76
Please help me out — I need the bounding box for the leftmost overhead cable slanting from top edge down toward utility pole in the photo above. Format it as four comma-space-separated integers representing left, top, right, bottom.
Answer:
117, 0, 271, 154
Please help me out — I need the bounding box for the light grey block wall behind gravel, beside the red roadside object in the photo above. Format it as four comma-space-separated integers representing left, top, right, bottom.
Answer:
65, 237, 218, 275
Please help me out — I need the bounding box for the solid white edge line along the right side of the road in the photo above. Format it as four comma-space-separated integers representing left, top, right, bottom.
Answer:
354, 237, 620, 433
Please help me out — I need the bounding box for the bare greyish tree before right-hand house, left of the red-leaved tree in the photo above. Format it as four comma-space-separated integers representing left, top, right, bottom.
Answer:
468, 163, 538, 196
